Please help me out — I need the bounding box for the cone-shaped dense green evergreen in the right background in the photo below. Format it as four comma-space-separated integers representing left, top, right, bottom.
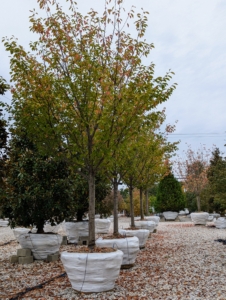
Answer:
155, 172, 185, 212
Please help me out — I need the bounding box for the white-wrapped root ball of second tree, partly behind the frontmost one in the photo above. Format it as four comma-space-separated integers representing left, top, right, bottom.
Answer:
96, 236, 140, 265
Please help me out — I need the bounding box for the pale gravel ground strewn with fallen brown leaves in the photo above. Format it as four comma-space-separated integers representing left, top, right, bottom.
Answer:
0, 218, 226, 300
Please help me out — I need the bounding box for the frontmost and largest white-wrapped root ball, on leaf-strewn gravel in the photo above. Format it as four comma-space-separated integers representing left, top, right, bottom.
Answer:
61, 250, 123, 293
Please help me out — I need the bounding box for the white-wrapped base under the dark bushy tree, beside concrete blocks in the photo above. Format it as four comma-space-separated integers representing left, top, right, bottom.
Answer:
18, 233, 62, 260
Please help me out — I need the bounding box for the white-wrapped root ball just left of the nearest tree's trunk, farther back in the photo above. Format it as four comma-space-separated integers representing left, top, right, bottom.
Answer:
64, 221, 89, 243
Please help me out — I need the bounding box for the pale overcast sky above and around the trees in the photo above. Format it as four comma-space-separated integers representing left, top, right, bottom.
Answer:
0, 0, 226, 159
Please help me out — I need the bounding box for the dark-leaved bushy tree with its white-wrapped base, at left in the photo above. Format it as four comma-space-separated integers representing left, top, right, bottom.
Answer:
2, 128, 73, 259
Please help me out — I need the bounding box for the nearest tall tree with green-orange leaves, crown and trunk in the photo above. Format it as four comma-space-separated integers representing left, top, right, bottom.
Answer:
4, 0, 175, 247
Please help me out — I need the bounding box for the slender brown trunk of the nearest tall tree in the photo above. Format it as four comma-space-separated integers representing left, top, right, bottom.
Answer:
89, 170, 95, 248
